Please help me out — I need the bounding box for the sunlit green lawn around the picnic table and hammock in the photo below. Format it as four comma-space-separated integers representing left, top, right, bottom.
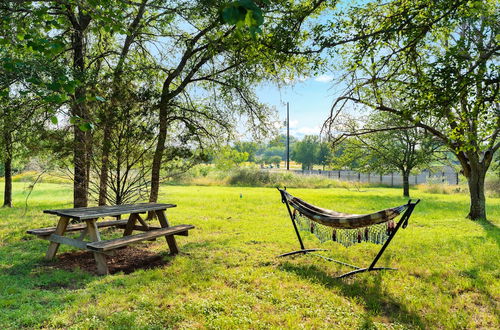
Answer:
0, 183, 500, 329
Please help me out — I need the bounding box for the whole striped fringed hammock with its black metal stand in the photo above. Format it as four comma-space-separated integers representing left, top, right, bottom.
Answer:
278, 188, 420, 278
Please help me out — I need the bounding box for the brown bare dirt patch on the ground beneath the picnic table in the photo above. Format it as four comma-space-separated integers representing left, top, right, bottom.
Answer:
50, 246, 169, 274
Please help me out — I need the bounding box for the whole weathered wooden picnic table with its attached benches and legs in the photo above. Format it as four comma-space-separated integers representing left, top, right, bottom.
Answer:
27, 203, 194, 275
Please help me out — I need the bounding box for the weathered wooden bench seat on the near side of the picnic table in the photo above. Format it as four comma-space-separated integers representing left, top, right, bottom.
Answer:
87, 225, 194, 251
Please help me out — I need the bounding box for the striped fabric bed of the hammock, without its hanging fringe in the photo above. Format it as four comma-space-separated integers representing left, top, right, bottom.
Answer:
280, 189, 408, 229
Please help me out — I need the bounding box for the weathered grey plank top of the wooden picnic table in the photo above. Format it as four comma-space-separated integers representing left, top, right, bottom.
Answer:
43, 203, 177, 220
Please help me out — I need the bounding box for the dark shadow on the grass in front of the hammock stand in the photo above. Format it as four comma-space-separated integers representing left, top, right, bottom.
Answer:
280, 262, 426, 328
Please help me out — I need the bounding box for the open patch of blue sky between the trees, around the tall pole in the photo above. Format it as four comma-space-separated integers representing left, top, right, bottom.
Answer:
257, 74, 338, 138
